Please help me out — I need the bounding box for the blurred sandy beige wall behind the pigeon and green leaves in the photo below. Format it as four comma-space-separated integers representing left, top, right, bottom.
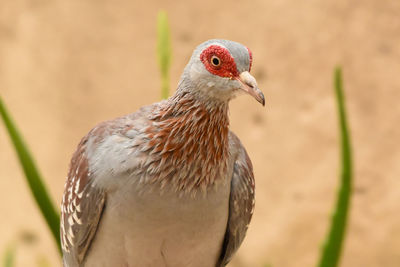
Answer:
0, 0, 400, 267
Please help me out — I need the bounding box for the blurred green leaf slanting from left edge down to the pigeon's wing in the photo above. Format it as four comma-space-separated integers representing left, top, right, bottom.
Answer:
0, 97, 61, 255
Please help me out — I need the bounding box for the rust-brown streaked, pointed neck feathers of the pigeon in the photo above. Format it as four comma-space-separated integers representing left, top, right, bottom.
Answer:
146, 94, 229, 194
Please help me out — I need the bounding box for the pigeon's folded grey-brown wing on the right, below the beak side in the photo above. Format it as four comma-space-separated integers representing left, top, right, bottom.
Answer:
218, 137, 254, 267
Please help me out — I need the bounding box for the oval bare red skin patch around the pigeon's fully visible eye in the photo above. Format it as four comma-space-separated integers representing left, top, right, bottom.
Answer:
200, 45, 239, 78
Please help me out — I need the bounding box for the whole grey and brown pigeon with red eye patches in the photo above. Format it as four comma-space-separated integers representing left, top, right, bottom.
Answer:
60, 39, 265, 267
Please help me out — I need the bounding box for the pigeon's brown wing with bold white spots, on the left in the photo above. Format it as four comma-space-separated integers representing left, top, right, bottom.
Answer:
60, 137, 106, 267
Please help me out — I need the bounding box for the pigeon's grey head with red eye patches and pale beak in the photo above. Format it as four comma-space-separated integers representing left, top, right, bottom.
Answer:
179, 39, 265, 105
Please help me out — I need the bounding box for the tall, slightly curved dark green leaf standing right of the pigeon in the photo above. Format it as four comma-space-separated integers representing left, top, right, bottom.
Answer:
318, 67, 352, 267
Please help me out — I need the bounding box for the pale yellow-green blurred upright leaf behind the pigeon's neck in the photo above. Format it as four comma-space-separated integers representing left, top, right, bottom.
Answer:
157, 11, 171, 99
